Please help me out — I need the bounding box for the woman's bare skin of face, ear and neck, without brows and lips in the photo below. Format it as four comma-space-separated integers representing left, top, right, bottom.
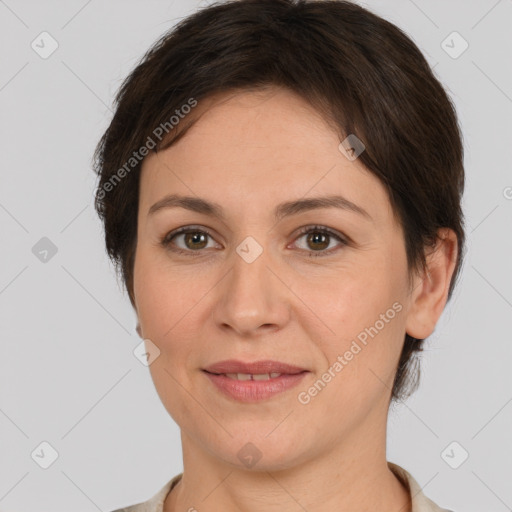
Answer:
133, 88, 457, 512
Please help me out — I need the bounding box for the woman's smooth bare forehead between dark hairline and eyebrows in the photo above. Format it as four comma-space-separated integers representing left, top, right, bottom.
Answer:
136, 88, 387, 226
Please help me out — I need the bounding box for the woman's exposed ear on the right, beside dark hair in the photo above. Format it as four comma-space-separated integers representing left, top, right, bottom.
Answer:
405, 228, 458, 339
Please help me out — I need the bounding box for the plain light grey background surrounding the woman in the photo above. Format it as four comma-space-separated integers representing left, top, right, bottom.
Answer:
0, 0, 512, 512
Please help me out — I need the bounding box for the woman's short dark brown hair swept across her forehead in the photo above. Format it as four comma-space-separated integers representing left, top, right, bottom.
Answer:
94, 0, 465, 400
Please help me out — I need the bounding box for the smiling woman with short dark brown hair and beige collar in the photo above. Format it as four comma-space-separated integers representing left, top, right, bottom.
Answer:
96, 0, 465, 512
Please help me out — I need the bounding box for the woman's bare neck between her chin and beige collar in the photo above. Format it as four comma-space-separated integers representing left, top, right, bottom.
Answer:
164, 412, 411, 512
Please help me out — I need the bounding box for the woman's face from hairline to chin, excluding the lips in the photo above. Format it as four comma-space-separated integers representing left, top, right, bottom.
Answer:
134, 89, 418, 469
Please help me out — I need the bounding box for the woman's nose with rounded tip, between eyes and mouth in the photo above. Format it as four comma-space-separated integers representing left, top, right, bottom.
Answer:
212, 240, 291, 337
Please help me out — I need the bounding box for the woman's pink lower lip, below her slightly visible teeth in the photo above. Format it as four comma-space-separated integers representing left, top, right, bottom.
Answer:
204, 371, 308, 402
